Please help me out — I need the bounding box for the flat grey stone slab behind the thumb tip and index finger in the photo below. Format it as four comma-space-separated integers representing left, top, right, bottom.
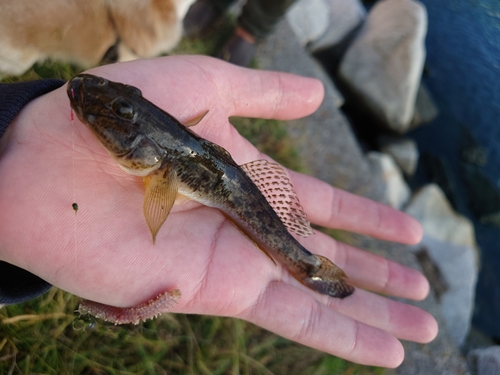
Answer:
255, 20, 383, 200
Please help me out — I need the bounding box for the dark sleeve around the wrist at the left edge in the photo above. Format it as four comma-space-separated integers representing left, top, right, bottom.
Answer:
0, 79, 64, 304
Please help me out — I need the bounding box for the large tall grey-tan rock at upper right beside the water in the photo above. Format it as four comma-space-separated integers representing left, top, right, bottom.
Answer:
339, 0, 427, 133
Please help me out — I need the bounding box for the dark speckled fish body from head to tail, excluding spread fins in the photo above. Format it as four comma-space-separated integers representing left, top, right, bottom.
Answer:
67, 74, 354, 298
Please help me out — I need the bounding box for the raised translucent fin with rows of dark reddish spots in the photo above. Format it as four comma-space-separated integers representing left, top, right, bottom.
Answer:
241, 160, 313, 237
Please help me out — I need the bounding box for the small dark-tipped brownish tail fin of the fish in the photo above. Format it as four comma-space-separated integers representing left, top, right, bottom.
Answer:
302, 255, 354, 298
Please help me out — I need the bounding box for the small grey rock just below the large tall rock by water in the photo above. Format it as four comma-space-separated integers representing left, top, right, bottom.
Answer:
379, 137, 419, 177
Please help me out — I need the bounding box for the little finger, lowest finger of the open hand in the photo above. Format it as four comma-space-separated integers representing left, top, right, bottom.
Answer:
239, 282, 404, 367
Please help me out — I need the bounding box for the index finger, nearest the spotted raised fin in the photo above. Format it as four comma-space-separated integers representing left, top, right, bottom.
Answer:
289, 171, 422, 244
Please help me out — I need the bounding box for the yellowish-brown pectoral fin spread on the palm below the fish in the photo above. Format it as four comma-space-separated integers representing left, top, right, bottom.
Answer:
143, 164, 179, 243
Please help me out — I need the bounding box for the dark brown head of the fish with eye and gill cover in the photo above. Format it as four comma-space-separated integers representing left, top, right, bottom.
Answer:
67, 74, 163, 176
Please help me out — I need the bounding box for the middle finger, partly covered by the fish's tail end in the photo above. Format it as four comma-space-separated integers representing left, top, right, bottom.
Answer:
301, 232, 429, 301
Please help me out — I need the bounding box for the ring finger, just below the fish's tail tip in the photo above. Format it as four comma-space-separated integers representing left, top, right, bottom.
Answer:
325, 289, 438, 343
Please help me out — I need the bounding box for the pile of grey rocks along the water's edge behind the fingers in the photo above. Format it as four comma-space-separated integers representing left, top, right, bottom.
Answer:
256, 0, 490, 374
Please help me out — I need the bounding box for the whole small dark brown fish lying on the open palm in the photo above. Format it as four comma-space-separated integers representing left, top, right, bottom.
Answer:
67, 74, 354, 298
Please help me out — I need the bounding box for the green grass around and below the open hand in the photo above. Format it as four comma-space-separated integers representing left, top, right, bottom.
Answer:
0, 20, 384, 375
